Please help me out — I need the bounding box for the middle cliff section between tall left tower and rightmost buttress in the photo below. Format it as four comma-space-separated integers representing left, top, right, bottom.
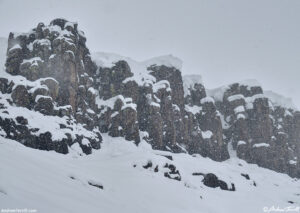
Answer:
97, 56, 229, 161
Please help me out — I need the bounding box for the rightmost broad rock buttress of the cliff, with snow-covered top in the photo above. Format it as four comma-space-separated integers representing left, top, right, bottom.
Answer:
209, 81, 300, 177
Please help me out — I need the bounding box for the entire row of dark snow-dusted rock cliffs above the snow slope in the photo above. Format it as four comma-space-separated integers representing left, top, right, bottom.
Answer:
0, 19, 300, 177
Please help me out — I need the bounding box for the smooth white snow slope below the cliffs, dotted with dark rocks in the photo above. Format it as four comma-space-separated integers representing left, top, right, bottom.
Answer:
0, 134, 300, 213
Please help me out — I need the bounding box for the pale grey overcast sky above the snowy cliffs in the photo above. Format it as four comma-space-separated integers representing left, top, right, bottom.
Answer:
0, 0, 300, 108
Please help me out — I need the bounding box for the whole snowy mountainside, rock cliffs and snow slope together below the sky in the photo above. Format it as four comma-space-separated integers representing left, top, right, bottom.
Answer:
0, 19, 300, 212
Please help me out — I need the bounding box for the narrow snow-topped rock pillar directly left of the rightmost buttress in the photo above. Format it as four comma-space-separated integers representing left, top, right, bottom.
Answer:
184, 75, 229, 161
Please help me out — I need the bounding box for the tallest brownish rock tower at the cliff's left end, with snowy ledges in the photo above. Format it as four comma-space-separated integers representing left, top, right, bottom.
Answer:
1, 19, 101, 153
